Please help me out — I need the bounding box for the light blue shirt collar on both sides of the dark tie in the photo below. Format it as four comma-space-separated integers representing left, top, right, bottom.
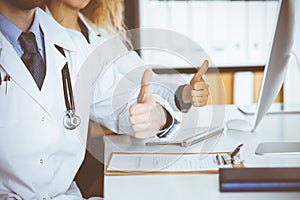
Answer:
0, 11, 43, 49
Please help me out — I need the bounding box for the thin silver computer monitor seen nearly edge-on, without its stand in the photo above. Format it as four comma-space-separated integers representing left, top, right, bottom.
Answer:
252, 0, 300, 132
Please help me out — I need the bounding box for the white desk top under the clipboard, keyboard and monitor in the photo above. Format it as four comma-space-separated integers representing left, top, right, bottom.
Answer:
104, 105, 300, 200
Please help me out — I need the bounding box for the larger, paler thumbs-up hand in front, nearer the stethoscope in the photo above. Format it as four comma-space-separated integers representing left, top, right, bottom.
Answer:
129, 70, 167, 138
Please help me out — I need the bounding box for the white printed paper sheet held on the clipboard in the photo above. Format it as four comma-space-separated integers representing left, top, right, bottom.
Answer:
107, 153, 231, 172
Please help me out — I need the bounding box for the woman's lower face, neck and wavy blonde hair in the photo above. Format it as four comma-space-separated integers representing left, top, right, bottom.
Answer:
46, 0, 125, 45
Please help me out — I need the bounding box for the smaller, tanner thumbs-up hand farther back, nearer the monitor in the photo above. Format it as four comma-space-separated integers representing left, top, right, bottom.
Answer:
182, 60, 209, 107
